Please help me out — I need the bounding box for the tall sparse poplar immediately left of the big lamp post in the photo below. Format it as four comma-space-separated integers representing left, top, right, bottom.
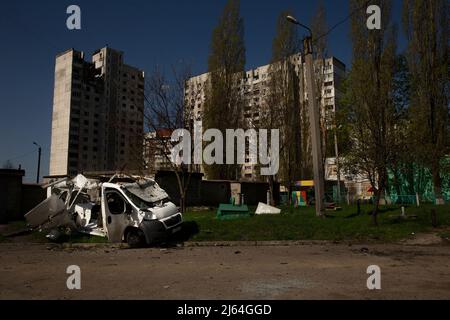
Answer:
261, 11, 302, 204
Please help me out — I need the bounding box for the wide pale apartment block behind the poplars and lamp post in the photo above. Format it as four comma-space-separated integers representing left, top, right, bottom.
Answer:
185, 54, 345, 180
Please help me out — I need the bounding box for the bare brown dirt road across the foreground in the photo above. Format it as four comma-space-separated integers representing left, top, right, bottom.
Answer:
0, 243, 450, 299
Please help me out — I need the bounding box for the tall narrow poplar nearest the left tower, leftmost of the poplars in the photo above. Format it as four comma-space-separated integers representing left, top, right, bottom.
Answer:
203, 0, 245, 180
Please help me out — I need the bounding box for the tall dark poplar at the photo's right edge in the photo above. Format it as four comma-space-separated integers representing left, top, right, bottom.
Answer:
403, 0, 450, 203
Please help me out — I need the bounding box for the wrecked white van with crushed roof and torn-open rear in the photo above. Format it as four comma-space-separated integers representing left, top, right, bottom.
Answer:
25, 175, 183, 247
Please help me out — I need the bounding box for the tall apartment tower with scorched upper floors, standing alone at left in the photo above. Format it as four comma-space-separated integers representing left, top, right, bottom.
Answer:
50, 47, 144, 176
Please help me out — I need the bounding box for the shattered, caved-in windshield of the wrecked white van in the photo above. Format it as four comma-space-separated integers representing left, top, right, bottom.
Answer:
122, 180, 169, 210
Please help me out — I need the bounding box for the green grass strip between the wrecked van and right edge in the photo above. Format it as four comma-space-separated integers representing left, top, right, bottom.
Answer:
184, 205, 450, 242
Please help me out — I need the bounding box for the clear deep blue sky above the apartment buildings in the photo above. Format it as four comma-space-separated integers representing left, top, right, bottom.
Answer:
0, 0, 401, 181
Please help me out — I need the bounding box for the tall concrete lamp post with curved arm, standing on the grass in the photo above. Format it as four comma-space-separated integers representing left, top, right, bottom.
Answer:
286, 16, 325, 216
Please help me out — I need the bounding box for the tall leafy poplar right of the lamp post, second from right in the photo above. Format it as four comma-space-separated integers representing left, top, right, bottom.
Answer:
343, 0, 399, 225
